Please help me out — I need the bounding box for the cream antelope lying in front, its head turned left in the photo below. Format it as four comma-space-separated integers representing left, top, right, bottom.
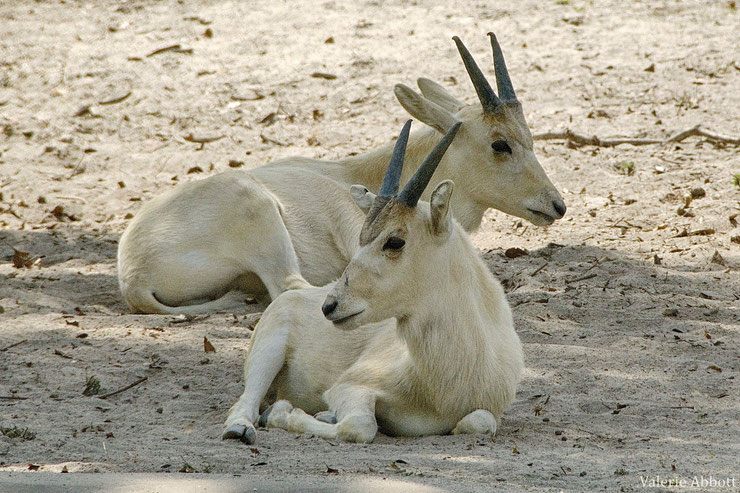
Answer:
223, 123, 523, 443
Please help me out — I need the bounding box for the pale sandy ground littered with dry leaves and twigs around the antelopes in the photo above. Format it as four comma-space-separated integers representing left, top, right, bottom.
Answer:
0, 0, 740, 491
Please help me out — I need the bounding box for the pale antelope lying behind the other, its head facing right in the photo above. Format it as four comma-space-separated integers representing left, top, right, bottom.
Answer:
118, 35, 565, 313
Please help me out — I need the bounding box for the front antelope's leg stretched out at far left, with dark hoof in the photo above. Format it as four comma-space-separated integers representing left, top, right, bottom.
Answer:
222, 320, 290, 444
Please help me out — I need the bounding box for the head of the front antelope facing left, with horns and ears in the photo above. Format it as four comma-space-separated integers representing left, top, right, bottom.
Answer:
322, 121, 460, 329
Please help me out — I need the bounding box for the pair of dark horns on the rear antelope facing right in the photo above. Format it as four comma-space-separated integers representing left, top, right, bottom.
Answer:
452, 33, 517, 113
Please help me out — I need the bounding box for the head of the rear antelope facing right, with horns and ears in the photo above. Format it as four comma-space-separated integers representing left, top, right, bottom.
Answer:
395, 33, 566, 226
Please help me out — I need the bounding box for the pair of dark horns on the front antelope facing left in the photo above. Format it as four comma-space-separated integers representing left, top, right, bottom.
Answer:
375, 120, 462, 207
